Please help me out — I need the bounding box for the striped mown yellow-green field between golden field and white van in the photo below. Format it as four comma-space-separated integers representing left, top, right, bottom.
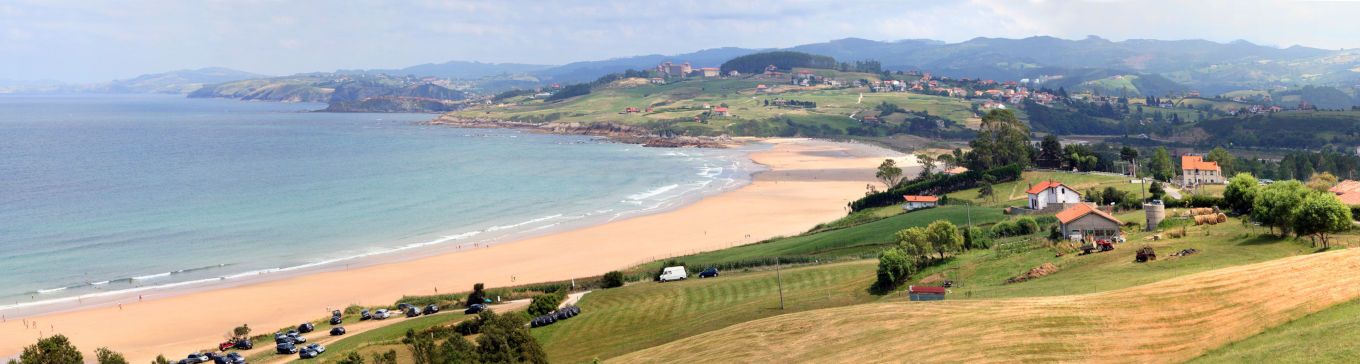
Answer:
533, 261, 876, 363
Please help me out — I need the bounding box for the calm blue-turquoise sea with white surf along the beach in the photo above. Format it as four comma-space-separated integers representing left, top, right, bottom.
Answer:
0, 95, 759, 310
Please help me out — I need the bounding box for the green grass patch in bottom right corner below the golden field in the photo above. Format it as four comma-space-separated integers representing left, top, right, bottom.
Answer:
1190, 300, 1360, 363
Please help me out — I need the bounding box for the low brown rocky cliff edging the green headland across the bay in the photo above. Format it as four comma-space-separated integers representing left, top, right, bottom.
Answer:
428, 114, 732, 148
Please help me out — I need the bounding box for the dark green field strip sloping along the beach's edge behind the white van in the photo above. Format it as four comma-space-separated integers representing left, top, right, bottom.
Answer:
642, 205, 1005, 272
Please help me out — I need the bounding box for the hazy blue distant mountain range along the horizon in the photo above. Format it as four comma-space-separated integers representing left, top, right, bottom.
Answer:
10, 37, 1360, 99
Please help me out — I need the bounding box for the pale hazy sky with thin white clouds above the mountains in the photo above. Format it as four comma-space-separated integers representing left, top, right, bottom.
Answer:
0, 0, 1360, 83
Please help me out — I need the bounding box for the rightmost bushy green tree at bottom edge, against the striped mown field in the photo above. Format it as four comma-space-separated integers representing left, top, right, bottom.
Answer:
477, 309, 548, 364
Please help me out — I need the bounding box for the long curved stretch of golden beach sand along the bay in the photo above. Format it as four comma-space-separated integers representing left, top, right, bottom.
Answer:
0, 139, 900, 363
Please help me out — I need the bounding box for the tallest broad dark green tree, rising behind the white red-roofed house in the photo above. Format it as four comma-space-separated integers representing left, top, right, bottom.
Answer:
968, 110, 1032, 170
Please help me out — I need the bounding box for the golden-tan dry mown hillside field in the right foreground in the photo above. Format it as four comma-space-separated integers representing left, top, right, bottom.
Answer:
612, 245, 1360, 363
